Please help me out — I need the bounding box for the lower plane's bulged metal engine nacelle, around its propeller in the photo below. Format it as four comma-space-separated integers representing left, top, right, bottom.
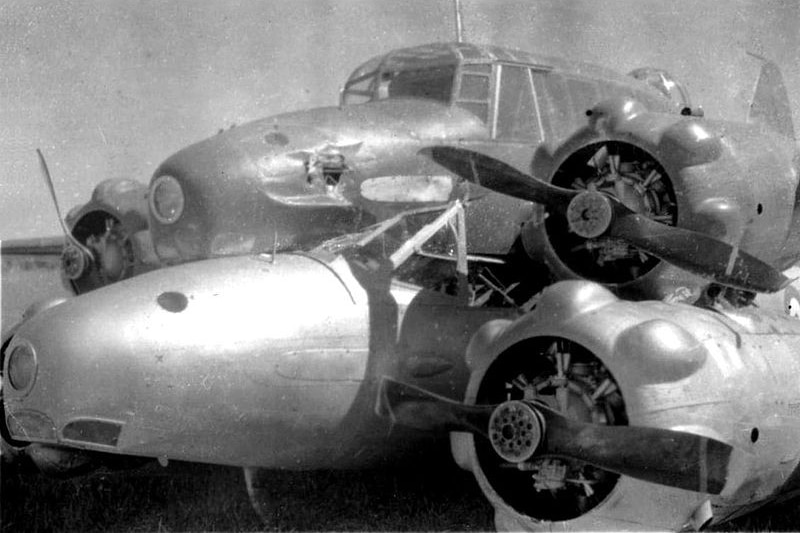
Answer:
452, 281, 800, 531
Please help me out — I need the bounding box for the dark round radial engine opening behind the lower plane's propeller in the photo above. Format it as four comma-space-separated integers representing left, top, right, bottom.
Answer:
475, 337, 627, 521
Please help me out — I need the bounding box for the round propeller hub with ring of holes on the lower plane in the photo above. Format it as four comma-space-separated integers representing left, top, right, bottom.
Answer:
489, 400, 545, 463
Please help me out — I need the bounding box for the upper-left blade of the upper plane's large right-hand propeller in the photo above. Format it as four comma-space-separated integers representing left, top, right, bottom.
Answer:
419, 146, 578, 210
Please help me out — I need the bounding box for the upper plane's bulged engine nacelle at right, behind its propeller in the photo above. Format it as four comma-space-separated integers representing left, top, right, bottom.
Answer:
522, 98, 798, 299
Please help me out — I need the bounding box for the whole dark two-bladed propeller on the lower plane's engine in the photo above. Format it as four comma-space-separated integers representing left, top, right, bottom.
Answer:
377, 377, 733, 494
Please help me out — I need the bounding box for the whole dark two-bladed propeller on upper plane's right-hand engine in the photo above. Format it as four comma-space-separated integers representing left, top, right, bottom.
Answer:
420, 146, 790, 292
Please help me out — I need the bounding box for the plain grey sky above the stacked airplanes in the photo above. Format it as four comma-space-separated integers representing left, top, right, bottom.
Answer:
0, 0, 800, 239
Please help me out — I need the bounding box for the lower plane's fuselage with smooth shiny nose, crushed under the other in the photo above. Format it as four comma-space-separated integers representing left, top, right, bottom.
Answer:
3, 248, 513, 469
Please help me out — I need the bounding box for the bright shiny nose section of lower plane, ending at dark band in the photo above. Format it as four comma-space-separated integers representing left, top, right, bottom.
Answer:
3, 254, 369, 467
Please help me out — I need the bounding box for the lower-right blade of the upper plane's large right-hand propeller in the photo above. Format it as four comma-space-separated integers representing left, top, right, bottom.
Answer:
608, 209, 791, 292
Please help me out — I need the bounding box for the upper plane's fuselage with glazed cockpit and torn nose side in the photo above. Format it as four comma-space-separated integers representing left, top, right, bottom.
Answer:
145, 43, 677, 264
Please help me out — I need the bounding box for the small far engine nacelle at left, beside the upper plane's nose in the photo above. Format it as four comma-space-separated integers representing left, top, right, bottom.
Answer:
62, 179, 159, 294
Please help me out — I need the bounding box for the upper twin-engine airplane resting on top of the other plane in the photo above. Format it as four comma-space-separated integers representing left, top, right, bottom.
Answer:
3, 43, 796, 299
